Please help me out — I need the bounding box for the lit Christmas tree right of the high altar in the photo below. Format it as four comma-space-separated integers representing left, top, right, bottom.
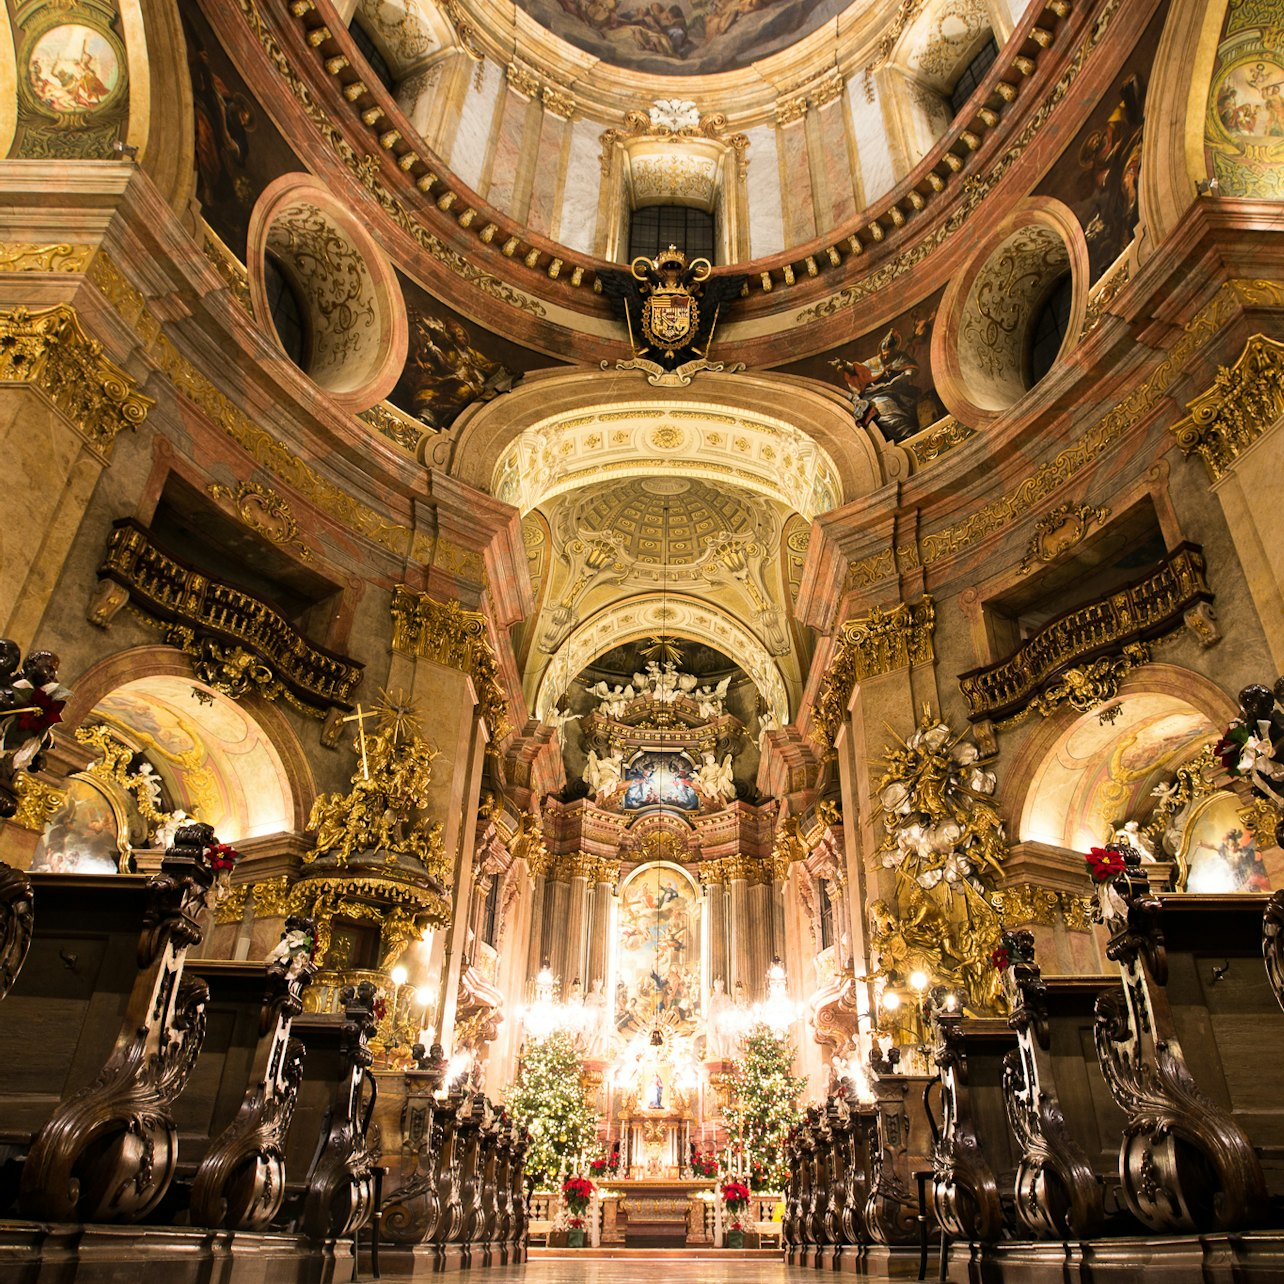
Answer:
725, 1026, 804, 1190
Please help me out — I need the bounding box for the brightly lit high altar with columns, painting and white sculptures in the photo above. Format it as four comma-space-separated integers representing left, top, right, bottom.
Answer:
518, 657, 783, 1181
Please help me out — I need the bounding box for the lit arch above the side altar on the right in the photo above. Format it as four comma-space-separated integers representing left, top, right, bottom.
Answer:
1004, 665, 1235, 851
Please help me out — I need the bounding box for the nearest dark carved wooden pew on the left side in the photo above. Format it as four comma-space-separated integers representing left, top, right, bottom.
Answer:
0, 824, 214, 1221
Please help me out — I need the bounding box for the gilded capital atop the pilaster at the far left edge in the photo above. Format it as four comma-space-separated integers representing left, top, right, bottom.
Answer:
0, 303, 155, 452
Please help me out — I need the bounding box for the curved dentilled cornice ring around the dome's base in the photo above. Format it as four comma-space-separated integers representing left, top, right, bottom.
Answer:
211, 0, 1154, 365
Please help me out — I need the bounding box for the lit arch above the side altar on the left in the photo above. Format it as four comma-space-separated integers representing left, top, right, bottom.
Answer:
64, 646, 316, 842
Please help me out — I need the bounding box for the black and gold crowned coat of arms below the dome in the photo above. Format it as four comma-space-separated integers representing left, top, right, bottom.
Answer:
597, 245, 745, 384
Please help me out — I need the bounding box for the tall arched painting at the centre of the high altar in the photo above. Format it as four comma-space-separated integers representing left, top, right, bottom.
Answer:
615, 864, 700, 1037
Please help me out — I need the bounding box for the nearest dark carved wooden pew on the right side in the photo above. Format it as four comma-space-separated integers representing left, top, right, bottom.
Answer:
1097, 847, 1284, 1231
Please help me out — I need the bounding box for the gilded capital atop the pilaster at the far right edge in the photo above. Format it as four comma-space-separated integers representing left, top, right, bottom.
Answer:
1172, 334, 1284, 482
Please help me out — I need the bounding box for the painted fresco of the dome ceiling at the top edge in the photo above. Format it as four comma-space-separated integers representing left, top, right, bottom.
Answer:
520, 0, 850, 76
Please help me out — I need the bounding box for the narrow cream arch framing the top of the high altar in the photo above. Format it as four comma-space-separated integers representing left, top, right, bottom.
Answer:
528, 593, 791, 725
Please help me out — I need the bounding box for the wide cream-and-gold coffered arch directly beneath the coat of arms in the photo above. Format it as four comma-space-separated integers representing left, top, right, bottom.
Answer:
441, 370, 904, 517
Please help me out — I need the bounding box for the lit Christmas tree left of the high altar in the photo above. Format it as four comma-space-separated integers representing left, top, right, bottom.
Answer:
507, 1030, 597, 1185
